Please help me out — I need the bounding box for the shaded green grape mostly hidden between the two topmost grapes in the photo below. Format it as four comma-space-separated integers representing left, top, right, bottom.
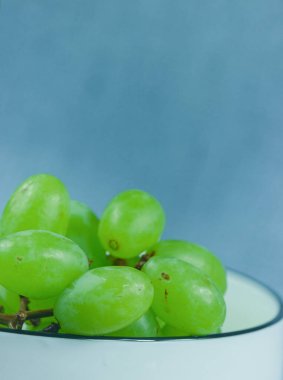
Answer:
66, 200, 110, 268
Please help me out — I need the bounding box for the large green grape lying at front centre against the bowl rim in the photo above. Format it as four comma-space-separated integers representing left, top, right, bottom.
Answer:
54, 267, 153, 335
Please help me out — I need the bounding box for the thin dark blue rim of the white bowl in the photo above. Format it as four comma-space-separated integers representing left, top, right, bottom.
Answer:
0, 267, 283, 342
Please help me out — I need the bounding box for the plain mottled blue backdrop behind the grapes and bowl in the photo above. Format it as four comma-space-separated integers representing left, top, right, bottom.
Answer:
0, 0, 283, 295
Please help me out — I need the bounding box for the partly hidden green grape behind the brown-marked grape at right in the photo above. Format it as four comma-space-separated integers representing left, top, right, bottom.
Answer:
149, 240, 227, 294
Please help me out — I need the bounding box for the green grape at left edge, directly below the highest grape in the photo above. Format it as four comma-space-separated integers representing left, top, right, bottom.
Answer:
0, 230, 88, 299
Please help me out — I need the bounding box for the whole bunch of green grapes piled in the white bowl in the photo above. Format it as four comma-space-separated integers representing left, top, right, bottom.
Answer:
0, 174, 226, 337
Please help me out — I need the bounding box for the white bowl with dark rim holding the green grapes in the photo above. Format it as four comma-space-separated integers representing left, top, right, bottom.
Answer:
0, 271, 283, 380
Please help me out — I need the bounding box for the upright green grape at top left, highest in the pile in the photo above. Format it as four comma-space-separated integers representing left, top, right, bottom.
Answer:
1, 174, 70, 235
